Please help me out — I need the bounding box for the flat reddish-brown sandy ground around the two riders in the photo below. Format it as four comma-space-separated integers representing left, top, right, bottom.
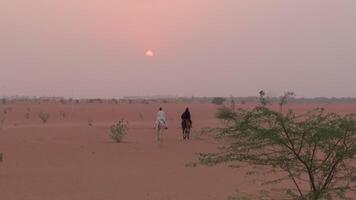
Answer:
0, 103, 356, 200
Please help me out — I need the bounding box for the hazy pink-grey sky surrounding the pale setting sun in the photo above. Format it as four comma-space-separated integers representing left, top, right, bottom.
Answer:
0, 0, 356, 98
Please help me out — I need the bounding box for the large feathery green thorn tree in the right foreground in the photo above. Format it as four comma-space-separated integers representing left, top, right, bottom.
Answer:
199, 92, 356, 200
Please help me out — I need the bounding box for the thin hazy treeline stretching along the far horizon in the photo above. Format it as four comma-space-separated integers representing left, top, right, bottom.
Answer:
0, 96, 356, 104
